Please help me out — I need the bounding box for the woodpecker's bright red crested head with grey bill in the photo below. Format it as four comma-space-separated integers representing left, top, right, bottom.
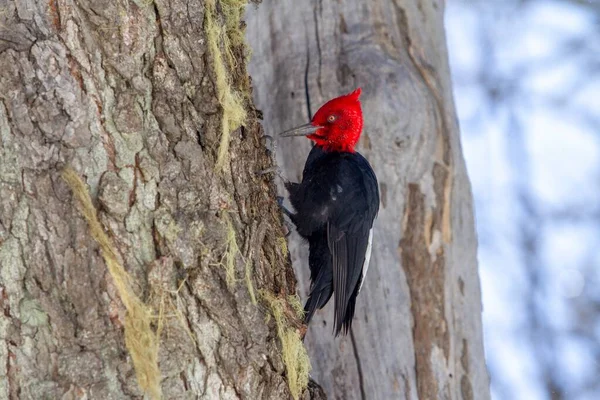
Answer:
282, 88, 363, 153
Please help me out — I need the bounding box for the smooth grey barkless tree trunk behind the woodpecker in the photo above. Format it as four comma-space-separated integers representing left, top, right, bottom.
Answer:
248, 0, 490, 400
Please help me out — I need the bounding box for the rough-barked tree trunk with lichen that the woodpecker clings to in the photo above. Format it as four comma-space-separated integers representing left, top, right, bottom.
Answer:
0, 0, 322, 399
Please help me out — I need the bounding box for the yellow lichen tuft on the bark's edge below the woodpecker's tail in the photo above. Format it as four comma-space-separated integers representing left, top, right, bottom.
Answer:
260, 290, 310, 400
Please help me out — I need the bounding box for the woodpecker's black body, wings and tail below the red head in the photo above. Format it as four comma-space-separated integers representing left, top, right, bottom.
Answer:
286, 146, 379, 336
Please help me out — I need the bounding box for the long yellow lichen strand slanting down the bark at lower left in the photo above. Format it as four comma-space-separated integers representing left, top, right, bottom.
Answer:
62, 167, 162, 399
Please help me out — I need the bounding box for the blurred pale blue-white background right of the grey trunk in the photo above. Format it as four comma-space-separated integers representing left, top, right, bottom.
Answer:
446, 0, 600, 400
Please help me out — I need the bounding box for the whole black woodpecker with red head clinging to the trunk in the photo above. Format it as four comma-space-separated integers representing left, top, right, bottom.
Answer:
280, 88, 379, 336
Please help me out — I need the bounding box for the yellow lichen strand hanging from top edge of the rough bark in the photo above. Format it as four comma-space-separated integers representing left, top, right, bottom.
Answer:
204, 0, 246, 170
